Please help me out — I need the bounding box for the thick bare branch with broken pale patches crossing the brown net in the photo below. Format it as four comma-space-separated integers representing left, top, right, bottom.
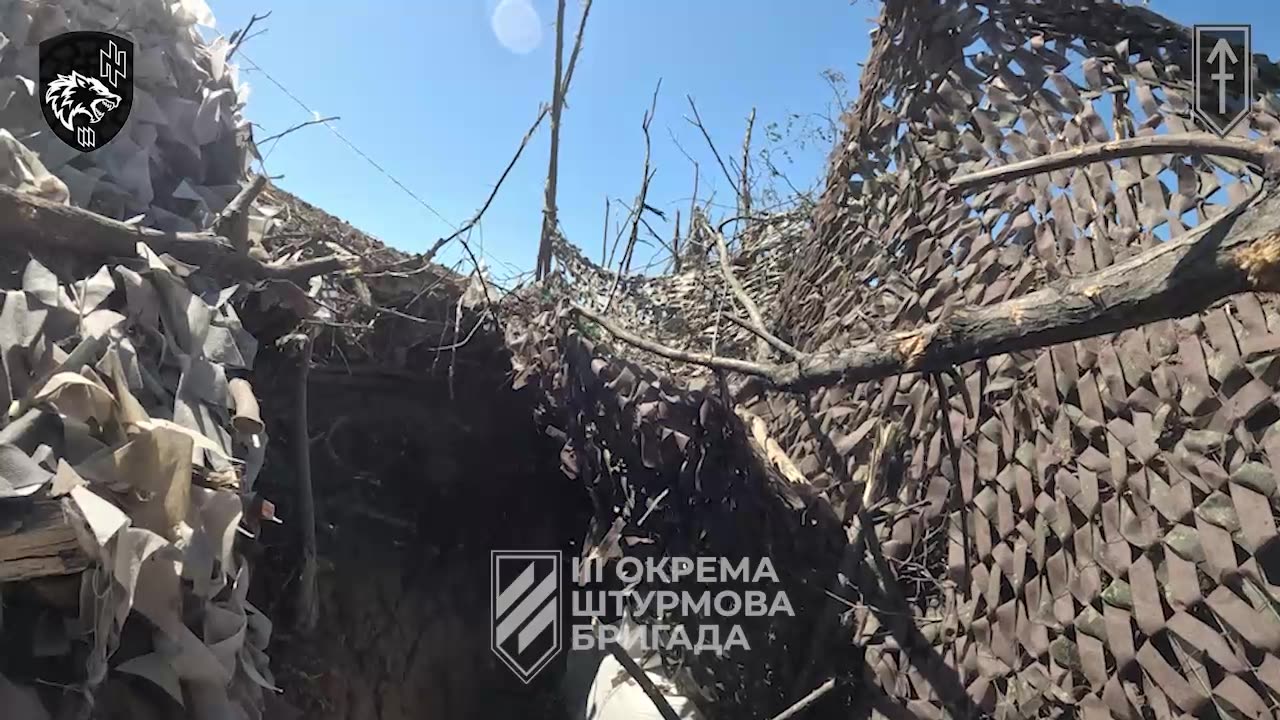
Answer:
572, 183, 1280, 392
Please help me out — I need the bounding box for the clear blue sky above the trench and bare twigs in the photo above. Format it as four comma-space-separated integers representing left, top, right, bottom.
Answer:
210, 0, 1280, 278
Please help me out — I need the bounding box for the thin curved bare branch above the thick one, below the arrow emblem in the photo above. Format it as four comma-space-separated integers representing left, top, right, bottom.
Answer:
950, 132, 1280, 190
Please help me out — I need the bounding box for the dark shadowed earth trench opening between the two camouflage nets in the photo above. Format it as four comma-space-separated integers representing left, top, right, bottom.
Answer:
241, 335, 590, 720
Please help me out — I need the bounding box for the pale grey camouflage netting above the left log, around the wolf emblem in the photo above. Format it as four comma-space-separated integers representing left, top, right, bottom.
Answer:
0, 0, 256, 231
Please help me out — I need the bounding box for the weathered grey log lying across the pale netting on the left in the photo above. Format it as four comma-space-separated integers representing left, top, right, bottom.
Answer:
0, 187, 353, 281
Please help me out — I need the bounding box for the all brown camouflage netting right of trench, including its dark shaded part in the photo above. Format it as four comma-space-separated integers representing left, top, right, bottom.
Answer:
512, 0, 1280, 717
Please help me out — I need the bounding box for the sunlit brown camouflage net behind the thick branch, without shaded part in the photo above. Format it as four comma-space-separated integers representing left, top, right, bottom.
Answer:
773, 1, 1280, 717
